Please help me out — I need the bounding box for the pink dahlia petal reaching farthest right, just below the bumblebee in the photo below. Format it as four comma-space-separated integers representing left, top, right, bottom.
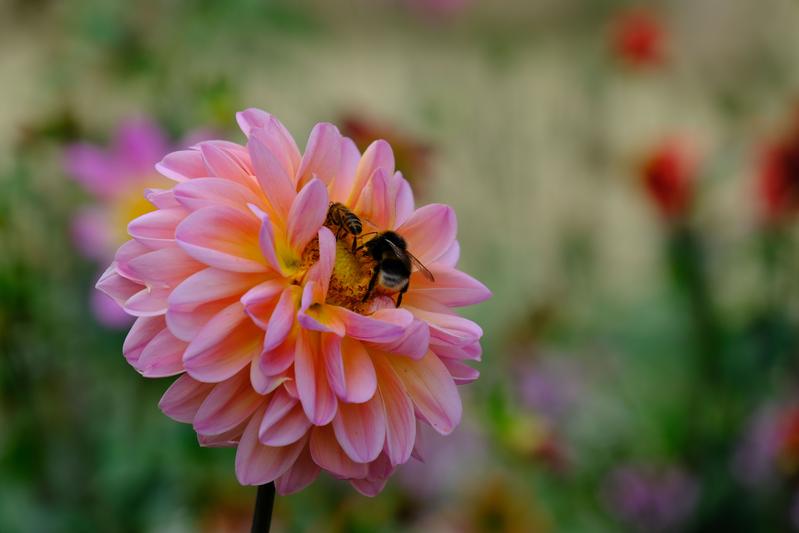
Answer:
409, 267, 491, 307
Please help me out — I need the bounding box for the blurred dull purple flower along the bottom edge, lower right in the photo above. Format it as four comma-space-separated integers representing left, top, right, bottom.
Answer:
603, 465, 699, 532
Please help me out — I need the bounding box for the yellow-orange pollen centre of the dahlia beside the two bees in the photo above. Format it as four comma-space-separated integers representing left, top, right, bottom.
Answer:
301, 232, 377, 314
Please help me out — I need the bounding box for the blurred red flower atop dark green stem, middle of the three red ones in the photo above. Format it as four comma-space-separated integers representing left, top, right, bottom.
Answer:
640, 139, 696, 220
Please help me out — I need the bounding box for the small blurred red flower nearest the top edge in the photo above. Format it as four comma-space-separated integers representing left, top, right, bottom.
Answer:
611, 8, 666, 67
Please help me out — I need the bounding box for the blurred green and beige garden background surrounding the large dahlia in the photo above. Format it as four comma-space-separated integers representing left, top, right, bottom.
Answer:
0, 0, 799, 533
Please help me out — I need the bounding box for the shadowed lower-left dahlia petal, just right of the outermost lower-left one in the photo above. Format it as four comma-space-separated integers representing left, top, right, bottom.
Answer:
194, 371, 264, 435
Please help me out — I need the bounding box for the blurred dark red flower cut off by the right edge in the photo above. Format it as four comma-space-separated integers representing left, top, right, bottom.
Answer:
757, 107, 799, 222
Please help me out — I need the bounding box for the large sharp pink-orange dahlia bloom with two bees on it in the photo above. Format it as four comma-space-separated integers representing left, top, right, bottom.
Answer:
97, 109, 490, 495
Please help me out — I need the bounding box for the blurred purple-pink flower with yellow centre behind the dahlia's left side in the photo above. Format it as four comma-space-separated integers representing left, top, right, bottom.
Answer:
64, 119, 205, 327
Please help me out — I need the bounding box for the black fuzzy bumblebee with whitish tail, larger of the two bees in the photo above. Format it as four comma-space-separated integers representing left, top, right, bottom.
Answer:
361, 231, 435, 307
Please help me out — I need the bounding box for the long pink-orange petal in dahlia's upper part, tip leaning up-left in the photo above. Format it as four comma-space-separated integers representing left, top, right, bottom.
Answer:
247, 137, 297, 226
